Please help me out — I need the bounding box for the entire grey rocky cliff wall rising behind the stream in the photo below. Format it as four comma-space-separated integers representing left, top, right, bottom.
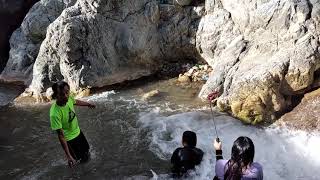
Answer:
1, 0, 320, 124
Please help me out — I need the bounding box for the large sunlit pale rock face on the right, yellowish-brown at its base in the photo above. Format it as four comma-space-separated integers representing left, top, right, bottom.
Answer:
197, 0, 320, 124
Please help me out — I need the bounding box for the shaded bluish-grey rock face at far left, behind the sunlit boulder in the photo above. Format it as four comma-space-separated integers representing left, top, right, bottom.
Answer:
0, 0, 75, 85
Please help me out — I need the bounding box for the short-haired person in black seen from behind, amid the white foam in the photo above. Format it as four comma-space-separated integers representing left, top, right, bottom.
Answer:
171, 131, 203, 177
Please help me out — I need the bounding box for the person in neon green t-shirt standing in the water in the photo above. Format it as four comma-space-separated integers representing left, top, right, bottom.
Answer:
50, 81, 95, 167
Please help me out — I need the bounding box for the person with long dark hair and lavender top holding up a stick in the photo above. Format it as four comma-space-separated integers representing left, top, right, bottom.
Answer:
214, 136, 263, 180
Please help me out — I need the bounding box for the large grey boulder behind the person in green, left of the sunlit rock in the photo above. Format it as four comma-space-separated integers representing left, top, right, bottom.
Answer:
16, 0, 205, 97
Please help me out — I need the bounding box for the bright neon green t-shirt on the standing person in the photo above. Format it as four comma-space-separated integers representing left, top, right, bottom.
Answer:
50, 96, 80, 141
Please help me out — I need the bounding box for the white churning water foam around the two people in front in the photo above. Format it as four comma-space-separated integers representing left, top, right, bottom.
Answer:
138, 108, 320, 180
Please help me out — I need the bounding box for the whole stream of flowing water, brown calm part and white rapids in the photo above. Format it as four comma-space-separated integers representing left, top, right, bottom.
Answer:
0, 81, 320, 180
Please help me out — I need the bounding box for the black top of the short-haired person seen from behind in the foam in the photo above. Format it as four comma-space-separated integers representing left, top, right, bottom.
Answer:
171, 147, 203, 177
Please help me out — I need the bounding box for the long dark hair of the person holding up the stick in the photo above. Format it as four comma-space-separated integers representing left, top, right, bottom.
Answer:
224, 136, 254, 180
